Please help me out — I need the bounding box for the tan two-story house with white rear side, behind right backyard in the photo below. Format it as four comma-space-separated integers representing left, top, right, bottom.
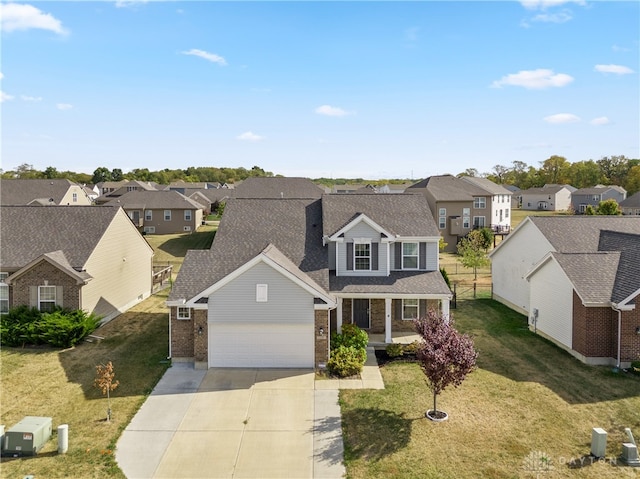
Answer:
406, 175, 511, 252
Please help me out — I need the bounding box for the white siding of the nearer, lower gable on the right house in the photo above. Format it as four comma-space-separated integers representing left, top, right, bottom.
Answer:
529, 260, 573, 349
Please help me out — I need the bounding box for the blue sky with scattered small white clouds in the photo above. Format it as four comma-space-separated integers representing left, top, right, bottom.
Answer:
0, 0, 640, 179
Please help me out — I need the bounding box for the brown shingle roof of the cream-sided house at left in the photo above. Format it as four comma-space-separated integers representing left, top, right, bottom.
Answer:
0, 206, 118, 271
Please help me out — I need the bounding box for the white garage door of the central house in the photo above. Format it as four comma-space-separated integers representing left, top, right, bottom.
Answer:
209, 321, 314, 368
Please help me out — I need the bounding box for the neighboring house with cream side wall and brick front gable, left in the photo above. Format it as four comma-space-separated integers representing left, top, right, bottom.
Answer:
0, 206, 153, 321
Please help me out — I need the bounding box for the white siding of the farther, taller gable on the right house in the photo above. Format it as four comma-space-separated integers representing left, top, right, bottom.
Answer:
491, 221, 553, 314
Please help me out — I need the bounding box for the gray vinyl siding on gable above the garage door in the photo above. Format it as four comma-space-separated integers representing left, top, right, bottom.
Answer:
208, 263, 314, 323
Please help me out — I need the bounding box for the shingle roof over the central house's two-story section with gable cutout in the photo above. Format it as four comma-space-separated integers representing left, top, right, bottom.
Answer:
322, 193, 440, 236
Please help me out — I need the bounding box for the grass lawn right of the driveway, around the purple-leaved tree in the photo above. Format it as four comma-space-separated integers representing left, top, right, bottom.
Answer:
340, 300, 640, 479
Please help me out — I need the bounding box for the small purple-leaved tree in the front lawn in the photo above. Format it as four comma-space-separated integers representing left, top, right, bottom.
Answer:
414, 310, 478, 419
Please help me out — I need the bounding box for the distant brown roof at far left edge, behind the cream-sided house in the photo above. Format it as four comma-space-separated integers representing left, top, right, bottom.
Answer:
0, 179, 79, 205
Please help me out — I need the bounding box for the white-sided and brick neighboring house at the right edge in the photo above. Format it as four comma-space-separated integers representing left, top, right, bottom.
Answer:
489, 216, 640, 364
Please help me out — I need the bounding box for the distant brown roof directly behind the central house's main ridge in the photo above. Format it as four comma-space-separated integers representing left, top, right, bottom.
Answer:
235, 177, 324, 199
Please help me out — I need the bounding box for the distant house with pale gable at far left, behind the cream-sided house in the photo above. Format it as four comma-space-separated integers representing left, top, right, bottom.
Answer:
0, 179, 92, 206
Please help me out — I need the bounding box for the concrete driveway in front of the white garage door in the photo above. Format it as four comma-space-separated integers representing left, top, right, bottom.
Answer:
116, 363, 345, 479
